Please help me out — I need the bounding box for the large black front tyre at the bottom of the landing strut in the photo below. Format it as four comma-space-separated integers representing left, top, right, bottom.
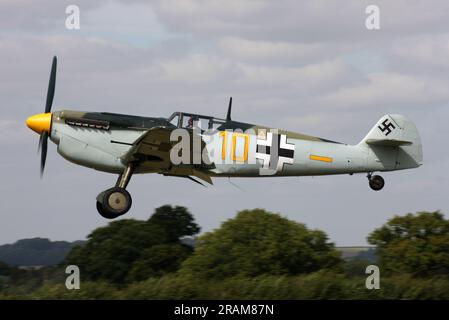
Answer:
97, 187, 132, 219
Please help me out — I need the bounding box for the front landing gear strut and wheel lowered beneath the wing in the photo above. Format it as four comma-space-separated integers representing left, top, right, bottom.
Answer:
97, 165, 134, 219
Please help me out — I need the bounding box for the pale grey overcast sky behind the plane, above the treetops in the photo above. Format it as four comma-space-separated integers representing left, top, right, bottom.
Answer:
0, 0, 449, 246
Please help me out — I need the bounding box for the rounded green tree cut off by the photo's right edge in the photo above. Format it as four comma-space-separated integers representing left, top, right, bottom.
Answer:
368, 211, 449, 276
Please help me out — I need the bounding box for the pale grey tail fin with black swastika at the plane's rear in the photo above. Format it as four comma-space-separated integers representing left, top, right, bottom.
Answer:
359, 114, 423, 169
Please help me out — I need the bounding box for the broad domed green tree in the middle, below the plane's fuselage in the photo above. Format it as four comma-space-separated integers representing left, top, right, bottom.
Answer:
180, 209, 341, 279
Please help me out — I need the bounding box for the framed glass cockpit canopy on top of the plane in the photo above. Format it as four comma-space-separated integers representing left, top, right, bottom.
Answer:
168, 112, 226, 130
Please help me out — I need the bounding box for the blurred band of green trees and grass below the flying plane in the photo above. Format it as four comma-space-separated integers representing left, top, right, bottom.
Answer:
0, 205, 449, 299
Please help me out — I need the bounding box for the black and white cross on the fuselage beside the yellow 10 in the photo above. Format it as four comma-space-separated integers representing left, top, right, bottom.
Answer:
256, 132, 295, 175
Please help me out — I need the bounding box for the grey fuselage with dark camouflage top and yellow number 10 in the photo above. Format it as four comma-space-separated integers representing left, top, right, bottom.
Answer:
50, 110, 422, 177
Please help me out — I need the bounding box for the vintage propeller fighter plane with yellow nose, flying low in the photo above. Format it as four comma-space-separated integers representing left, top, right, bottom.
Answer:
26, 56, 423, 219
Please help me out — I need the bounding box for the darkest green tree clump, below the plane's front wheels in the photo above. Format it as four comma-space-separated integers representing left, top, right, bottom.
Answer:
64, 206, 199, 283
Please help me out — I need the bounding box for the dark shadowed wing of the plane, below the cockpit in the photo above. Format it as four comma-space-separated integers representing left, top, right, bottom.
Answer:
122, 127, 213, 184
